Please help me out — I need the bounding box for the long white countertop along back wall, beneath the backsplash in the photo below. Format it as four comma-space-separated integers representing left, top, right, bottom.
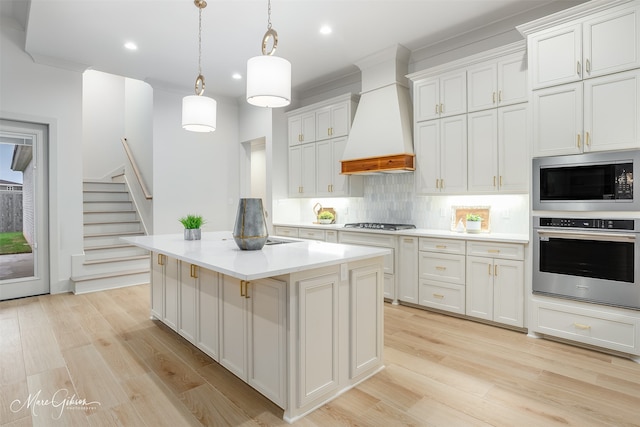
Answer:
273, 223, 529, 244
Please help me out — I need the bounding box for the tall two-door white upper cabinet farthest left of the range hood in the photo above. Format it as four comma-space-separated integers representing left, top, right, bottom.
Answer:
289, 143, 316, 197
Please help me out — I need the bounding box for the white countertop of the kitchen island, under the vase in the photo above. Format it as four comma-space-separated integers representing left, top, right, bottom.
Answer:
121, 231, 389, 280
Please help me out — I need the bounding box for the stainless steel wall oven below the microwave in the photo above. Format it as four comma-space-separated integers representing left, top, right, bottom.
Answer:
533, 217, 640, 310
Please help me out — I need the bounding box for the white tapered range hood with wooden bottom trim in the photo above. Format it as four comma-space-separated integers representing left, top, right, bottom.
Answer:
341, 45, 415, 175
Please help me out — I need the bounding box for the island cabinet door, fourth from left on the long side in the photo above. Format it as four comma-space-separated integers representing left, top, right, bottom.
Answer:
197, 268, 220, 362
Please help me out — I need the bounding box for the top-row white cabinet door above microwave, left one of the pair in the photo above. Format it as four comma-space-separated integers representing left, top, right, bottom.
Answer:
528, 23, 582, 89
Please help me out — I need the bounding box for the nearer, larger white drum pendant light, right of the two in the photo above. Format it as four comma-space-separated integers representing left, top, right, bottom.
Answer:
247, 0, 291, 108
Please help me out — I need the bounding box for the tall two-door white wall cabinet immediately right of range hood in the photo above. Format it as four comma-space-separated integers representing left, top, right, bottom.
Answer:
414, 114, 467, 194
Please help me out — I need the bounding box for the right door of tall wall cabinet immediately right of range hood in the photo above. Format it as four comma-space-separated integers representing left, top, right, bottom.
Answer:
440, 114, 467, 193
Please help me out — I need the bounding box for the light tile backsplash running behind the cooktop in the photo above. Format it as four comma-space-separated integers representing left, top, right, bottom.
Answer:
274, 173, 529, 234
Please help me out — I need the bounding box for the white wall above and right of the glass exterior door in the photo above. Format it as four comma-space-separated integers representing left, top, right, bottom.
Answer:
0, 21, 82, 293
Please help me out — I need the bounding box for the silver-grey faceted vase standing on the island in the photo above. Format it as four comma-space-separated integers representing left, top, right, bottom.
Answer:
233, 199, 269, 251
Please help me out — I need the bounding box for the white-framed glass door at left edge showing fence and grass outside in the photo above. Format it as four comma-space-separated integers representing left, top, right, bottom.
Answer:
0, 120, 50, 300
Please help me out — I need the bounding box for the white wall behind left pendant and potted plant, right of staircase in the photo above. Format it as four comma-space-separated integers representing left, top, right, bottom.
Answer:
153, 87, 239, 234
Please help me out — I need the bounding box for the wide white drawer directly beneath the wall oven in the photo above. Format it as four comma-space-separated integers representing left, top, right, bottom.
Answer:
533, 301, 640, 354
